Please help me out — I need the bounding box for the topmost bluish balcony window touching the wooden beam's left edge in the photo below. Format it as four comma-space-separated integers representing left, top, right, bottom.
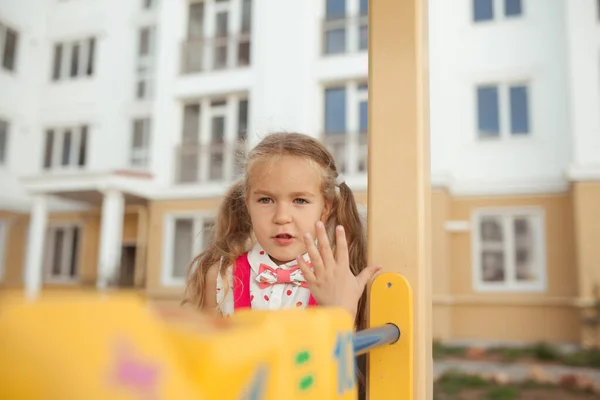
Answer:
323, 0, 369, 55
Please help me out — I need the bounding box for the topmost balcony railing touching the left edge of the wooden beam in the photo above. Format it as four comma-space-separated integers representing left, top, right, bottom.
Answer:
321, 15, 369, 56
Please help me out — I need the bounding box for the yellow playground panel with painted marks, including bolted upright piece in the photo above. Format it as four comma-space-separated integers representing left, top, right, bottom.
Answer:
0, 273, 412, 400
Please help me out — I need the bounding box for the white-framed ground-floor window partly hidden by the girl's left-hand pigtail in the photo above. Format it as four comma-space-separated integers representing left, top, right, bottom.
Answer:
163, 214, 215, 285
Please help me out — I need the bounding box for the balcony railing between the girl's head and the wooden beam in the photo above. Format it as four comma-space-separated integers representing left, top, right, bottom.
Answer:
322, 132, 368, 175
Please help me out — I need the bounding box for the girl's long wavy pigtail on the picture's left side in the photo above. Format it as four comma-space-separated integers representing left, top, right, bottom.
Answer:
182, 181, 252, 309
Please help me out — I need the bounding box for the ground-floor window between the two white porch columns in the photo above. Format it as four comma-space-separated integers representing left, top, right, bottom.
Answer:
44, 224, 82, 283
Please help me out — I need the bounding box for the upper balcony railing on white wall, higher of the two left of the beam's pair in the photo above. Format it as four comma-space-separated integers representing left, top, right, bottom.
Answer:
181, 33, 250, 74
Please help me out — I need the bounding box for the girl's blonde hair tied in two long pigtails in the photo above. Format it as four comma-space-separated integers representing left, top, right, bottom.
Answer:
184, 133, 367, 329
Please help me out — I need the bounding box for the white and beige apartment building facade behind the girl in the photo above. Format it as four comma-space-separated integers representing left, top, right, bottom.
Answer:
0, 0, 600, 343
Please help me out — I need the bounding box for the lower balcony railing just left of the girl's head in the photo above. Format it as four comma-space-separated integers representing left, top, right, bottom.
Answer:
175, 142, 246, 183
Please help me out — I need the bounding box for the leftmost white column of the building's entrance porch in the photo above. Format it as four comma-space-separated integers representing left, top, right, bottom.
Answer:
25, 195, 48, 299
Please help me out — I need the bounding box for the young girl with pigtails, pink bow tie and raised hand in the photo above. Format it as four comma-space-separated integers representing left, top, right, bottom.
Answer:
184, 133, 379, 329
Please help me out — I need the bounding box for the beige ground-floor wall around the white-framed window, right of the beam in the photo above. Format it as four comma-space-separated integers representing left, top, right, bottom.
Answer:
432, 190, 580, 342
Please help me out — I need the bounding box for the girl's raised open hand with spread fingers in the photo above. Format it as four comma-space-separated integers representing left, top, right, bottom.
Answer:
297, 221, 381, 318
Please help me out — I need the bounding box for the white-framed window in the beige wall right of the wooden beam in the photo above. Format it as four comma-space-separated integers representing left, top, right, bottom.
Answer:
472, 208, 546, 291
